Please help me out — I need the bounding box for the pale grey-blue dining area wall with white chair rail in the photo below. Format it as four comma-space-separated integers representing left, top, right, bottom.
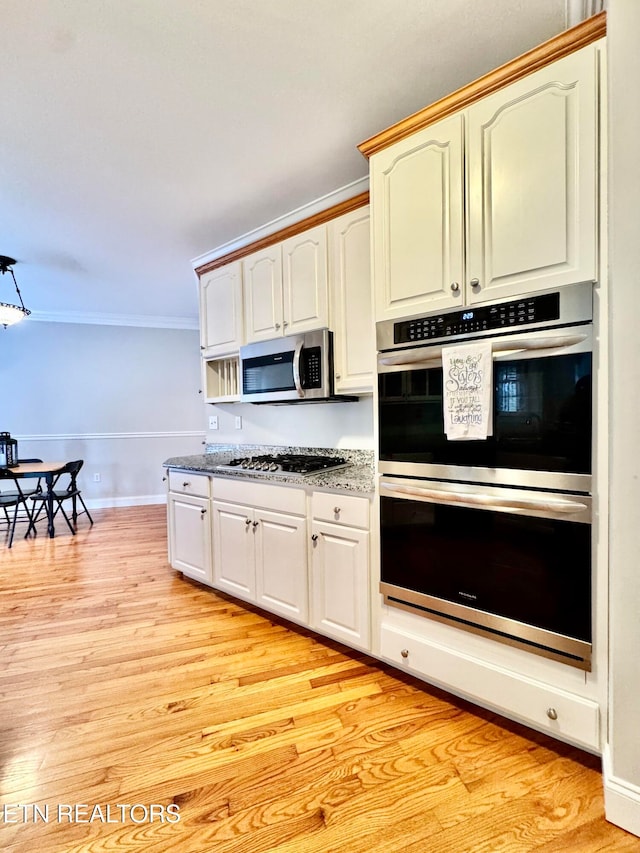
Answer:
0, 320, 204, 506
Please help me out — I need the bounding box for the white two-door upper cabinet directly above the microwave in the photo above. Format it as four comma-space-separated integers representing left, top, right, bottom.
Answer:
242, 225, 329, 342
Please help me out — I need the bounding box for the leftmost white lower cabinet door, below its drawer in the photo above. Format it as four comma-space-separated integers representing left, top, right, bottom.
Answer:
168, 493, 213, 584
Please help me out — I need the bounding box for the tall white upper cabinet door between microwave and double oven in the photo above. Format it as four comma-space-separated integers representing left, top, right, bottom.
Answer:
329, 205, 376, 394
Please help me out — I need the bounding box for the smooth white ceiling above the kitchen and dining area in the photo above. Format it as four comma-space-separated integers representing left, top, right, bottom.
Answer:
0, 0, 567, 327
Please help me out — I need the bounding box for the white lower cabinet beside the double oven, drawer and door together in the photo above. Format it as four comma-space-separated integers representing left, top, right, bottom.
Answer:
311, 492, 371, 651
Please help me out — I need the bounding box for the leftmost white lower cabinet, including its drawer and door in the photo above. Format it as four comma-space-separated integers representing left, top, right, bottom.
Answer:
167, 471, 213, 584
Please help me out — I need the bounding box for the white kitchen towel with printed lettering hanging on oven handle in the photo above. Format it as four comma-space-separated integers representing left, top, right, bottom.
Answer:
442, 341, 493, 441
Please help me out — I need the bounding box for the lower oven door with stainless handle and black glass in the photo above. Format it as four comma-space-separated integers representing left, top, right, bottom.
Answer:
380, 477, 591, 670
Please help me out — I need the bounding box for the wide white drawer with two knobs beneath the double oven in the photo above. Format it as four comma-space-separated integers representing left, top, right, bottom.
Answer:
380, 625, 600, 752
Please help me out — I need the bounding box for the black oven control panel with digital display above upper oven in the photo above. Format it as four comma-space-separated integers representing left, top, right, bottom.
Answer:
393, 292, 560, 344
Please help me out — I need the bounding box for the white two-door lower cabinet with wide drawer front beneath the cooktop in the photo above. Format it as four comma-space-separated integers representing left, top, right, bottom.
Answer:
212, 479, 309, 624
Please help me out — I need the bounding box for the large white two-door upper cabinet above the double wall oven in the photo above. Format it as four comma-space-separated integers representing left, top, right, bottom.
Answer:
371, 44, 598, 320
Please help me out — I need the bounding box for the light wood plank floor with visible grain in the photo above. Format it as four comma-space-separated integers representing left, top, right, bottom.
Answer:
0, 507, 640, 853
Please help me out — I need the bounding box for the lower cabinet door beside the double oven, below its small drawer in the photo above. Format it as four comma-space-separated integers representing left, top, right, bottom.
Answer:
311, 521, 370, 650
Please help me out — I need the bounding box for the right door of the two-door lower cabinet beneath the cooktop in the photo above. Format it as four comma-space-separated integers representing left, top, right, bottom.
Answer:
255, 509, 309, 624
